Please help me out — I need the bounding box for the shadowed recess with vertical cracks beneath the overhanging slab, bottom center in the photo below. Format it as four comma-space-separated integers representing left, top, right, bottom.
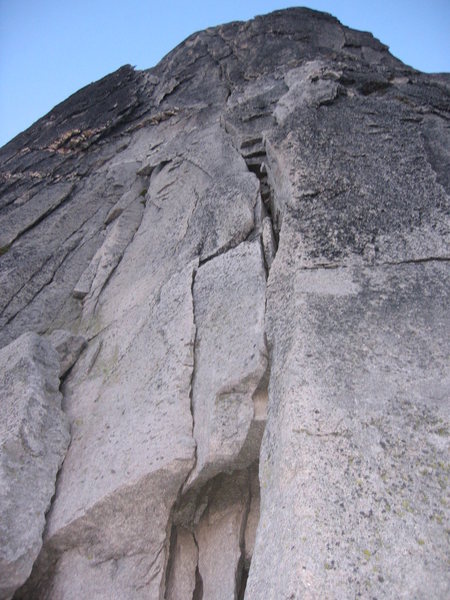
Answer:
164, 462, 259, 600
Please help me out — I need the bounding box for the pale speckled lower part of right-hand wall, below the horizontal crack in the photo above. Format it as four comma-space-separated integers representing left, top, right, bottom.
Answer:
246, 262, 450, 599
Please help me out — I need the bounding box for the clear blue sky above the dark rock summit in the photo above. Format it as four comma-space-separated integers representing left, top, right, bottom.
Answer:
0, 0, 450, 146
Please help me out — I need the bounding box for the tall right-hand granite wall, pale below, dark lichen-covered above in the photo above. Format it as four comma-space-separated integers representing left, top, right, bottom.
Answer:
246, 49, 450, 599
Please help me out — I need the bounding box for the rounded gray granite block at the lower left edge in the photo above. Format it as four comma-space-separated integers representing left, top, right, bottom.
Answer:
0, 333, 69, 599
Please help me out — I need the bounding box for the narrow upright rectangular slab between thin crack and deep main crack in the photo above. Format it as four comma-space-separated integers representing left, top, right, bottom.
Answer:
186, 241, 267, 487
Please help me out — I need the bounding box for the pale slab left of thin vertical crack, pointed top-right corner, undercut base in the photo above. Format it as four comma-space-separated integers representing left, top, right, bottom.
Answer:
39, 265, 199, 595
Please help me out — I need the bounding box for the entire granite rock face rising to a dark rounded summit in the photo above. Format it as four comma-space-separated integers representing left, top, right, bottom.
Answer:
0, 9, 450, 600
